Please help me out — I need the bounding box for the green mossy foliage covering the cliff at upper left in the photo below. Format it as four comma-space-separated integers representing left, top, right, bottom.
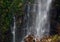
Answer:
0, 0, 25, 42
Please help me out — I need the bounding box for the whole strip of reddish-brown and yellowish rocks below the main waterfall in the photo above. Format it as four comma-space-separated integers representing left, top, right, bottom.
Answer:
24, 35, 60, 42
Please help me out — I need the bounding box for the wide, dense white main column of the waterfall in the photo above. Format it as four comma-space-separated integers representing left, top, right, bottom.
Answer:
35, 0, 52, 38
